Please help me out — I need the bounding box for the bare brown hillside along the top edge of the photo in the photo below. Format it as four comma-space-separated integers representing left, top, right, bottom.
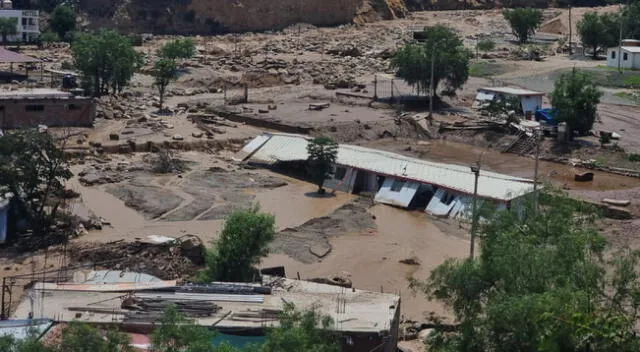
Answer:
72, 0, 602, 34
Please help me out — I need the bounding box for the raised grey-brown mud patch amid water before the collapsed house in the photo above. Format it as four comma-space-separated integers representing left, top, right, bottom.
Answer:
270, 198, 376, 264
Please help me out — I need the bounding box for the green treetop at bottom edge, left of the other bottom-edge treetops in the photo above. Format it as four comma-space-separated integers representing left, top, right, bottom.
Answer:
57, 322, 134, 352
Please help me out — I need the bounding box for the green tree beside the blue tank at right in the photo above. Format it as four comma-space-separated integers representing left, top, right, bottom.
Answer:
551, 68, 602, 139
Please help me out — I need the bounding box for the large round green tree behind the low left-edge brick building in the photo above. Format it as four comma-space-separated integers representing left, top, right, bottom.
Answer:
70, 30, 142, 96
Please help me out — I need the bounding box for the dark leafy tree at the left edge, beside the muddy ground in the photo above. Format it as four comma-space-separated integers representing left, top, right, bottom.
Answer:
0, 130, 72, 243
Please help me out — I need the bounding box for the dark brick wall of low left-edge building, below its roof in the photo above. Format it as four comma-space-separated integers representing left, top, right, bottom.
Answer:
0, 98, 95, 129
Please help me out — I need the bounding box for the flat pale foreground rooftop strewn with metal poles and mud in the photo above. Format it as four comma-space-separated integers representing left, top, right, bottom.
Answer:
14, 278, 400, 332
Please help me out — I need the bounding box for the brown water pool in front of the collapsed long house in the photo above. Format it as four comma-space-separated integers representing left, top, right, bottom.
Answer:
262, 205, 469, 319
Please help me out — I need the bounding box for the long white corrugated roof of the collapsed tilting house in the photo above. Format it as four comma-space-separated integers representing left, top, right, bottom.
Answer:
242, 134, 533, 201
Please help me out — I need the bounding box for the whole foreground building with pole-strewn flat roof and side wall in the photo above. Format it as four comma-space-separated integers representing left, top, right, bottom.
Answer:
14, 271, 400, 352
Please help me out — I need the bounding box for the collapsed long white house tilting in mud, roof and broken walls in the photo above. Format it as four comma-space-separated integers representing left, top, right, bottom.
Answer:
239, 133, 533, 217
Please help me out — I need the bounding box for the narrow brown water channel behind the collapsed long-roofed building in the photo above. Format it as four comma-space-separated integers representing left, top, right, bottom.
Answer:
370, 140, 640, 191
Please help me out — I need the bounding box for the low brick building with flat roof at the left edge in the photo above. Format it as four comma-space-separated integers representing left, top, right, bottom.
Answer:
0, 89, 96, 129
